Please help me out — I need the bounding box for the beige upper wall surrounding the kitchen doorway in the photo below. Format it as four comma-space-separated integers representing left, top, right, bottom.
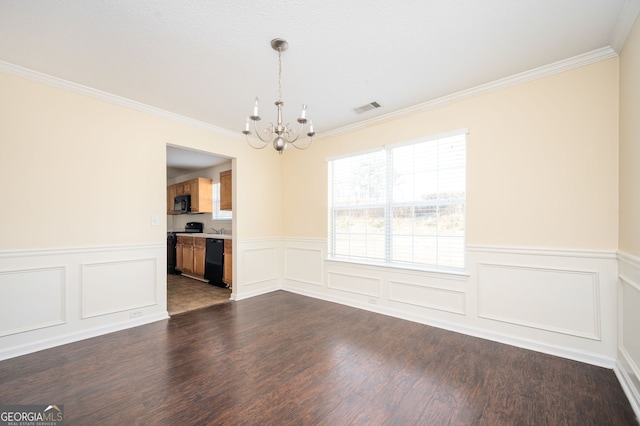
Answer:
0, 73, 281, 250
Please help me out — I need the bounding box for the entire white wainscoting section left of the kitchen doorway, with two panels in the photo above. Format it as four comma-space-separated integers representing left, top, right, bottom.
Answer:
0, 243, 168, 360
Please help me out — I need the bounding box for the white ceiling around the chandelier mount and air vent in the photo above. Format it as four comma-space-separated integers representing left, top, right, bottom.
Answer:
0, 0, 640, 171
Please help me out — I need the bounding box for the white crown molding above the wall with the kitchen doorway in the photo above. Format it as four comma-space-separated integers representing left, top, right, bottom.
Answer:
0, 61, 242, 139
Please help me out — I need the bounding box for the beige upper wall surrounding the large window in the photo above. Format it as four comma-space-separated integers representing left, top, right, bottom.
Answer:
283, 58, 620, 250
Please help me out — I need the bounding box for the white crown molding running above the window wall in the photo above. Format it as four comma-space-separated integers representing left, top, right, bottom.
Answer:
322, 47, 618, 137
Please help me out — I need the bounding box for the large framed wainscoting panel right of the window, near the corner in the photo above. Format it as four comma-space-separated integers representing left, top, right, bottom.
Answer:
478, 263, 600, 340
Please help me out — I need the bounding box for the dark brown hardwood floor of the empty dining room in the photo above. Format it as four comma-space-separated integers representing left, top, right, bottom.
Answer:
0, 291, 636, 426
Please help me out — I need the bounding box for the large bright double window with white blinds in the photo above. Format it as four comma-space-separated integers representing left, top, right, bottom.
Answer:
328, 130, 467, 269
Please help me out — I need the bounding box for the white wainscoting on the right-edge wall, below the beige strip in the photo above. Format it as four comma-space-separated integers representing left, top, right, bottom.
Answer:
615, 253, 640, 419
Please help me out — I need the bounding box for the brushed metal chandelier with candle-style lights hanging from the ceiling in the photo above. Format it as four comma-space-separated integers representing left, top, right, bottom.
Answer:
242, 38, 316, 154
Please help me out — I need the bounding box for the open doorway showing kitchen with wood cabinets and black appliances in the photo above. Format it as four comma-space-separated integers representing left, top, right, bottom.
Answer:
165, 145, 233, 315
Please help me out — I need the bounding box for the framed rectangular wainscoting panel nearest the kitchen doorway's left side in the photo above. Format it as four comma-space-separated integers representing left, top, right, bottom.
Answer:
81, 259, 158, 318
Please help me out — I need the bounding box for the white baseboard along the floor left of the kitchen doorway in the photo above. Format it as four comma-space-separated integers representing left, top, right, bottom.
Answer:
0, 311, 169, 361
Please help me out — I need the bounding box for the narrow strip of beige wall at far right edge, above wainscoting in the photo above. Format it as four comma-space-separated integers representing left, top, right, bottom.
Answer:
619, 15, 640, 256
